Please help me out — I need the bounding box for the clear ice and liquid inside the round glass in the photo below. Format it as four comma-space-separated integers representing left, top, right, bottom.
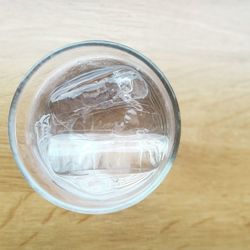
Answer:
34, 60, 168, 199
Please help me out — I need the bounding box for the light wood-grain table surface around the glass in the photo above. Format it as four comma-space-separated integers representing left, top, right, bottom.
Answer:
0, 0, 250, 250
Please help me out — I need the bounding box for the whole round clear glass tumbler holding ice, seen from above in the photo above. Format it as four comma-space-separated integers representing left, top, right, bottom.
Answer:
9, 41, 180, 214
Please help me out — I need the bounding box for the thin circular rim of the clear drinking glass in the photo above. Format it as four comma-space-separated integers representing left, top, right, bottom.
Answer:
8, 40, 181, 214
